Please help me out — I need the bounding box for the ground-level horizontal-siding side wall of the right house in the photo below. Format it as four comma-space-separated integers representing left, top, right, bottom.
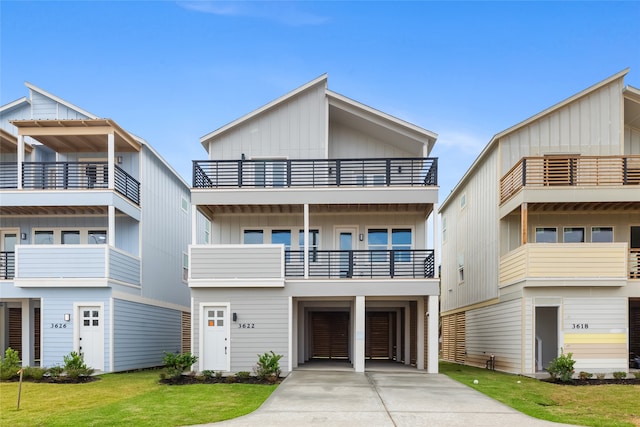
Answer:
466, 299, 523, 372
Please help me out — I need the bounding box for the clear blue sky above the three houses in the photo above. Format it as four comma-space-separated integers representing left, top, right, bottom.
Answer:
0, 0, 640, 196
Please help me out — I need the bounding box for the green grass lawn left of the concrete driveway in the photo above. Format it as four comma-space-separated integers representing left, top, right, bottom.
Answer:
0, 370, 276, 426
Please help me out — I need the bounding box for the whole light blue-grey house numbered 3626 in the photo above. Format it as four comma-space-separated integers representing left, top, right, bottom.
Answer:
0, 83, 191, 372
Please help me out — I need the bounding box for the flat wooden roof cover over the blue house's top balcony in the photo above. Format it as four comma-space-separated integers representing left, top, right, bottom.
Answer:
11, 119, 142, 153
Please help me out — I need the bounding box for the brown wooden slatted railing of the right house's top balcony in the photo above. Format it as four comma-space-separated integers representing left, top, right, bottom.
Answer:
500, 155, 640, 204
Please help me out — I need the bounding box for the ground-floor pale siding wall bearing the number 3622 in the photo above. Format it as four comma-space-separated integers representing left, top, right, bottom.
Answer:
192, 289, 290, 372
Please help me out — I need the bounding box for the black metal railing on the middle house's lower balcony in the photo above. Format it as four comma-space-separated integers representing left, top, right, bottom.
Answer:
285, 249, 435, 279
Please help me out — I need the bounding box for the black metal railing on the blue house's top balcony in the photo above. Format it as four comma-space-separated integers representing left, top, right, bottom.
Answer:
0, 162, 140, 205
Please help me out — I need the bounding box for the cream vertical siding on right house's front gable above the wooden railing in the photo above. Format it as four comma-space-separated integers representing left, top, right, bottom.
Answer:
500, 78, 623, 174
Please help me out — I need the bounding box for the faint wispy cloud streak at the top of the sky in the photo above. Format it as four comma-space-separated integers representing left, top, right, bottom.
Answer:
178, 0, 329, 26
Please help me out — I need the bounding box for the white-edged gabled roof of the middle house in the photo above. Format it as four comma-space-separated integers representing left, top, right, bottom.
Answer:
200, 73, 438, 154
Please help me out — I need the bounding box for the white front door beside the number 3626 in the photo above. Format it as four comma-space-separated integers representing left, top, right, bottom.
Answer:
78, 306, 104, 371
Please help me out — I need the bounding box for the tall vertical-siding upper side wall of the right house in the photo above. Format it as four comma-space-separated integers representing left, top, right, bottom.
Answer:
441, 145, 499, 311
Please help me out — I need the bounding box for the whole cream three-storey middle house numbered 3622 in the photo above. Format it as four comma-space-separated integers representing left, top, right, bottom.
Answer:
188, 75, 439, 373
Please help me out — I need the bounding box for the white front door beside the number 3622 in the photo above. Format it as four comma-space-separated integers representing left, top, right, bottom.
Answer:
202, 306, 230, 371
